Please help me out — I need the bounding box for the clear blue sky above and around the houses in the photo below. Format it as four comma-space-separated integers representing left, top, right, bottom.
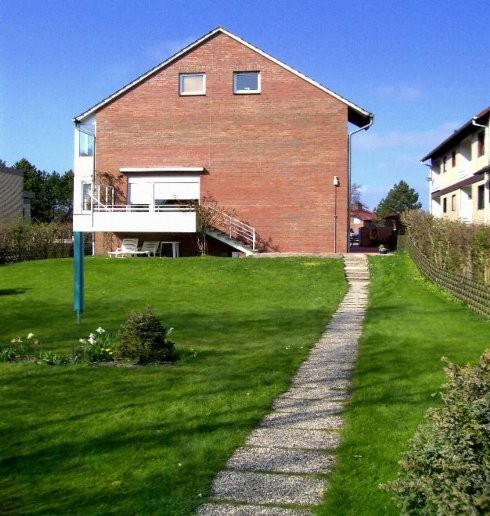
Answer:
0, 0, 490, 208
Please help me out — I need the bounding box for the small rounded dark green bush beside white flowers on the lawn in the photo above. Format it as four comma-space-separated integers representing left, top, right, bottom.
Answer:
116, 306, 175, 364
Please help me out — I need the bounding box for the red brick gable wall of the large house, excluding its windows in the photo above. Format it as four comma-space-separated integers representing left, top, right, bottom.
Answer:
96, 34, 347, 252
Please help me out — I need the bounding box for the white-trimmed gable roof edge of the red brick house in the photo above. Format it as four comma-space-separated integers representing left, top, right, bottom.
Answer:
73, 27, 373, 127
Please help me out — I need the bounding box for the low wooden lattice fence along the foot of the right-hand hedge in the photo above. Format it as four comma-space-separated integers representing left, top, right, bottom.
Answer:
405, 238, 490, 317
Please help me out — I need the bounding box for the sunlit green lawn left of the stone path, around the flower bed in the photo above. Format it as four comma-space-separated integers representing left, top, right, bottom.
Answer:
0, 258, 346, 515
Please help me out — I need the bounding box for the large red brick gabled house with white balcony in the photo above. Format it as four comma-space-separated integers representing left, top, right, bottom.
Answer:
73, 28, 372, 255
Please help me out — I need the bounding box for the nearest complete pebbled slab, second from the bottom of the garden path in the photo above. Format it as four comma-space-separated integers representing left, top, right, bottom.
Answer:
213, 471, 326, 505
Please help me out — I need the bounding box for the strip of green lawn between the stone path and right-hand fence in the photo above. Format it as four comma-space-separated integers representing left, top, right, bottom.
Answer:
318, 254, 490, 516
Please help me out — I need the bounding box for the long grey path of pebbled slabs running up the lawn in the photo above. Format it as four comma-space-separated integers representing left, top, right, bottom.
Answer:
197, 253, 369, 516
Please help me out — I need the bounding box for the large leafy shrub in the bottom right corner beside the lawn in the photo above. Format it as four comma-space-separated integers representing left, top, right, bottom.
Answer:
381, 349, 490, 515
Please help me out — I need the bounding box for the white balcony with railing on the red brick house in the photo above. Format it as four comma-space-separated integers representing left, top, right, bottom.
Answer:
73, 203, 196, 233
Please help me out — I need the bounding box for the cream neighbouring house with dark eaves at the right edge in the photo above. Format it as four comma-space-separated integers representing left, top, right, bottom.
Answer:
422, 107, 490, 224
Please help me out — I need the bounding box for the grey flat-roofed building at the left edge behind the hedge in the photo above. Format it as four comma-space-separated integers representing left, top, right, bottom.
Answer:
0, 165, 33, 221
